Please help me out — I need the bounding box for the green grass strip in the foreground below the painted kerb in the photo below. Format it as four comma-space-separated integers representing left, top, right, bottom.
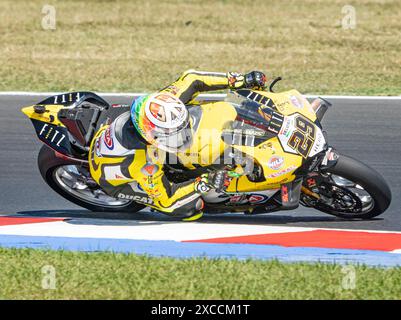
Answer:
0, 249, 401, 299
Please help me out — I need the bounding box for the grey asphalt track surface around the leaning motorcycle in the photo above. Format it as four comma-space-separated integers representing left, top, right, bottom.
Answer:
0, 95, 401, 231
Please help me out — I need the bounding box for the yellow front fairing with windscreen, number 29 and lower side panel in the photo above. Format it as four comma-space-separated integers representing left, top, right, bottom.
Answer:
226, 90, 326, 191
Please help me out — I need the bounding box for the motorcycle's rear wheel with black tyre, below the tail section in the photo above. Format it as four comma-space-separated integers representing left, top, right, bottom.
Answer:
38, 146, 145, 212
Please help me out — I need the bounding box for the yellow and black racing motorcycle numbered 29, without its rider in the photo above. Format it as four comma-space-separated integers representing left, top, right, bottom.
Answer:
22, 78, 391, 219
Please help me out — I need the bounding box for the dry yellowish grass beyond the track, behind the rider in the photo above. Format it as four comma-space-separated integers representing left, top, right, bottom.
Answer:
0, 0, 401, 95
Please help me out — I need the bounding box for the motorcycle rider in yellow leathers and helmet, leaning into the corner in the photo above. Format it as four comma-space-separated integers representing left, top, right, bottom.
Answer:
89, 70, 266, 221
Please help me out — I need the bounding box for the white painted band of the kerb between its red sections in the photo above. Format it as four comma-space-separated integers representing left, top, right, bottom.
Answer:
0, 219, 401, 242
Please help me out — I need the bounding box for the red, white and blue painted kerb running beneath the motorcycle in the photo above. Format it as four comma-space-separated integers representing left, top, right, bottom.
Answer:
0, 216, 401, 265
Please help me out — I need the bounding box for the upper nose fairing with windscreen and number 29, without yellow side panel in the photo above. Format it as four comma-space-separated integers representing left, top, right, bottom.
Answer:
226, 90, 326, 159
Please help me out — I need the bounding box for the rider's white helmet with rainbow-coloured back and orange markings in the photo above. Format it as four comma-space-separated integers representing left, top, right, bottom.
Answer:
131, 92, 192, 152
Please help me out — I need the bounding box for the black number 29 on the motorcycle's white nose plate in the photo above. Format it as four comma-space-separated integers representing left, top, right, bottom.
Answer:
288, 116, 315, 158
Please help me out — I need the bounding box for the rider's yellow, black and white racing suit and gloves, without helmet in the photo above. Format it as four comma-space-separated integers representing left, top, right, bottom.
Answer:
89, 70, 266, 217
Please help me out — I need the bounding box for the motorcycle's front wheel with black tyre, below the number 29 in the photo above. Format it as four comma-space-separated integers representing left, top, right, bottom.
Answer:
301, 155, 391, 219
